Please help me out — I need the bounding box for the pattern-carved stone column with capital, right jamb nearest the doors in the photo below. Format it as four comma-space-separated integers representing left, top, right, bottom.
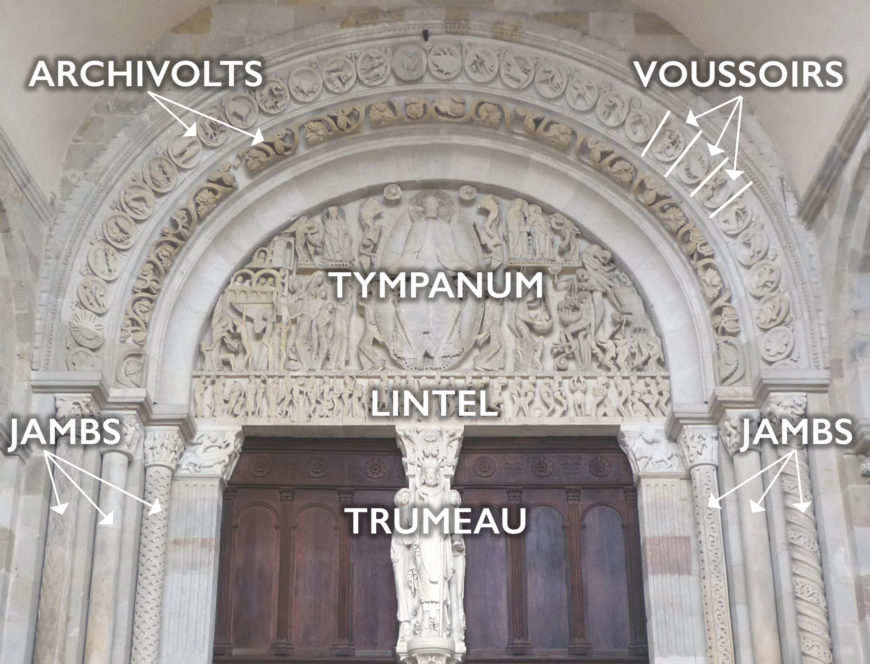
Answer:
680, 425, 734, 664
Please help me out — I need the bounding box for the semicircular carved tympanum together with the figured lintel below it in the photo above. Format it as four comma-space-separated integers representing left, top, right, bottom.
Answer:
194, 184, 669, 420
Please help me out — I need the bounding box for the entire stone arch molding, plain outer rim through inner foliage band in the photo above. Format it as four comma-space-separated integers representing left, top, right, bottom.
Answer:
41, 13, 823, 400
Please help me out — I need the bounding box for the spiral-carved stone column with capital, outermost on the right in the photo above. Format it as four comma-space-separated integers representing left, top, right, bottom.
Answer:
764, 393, 834, 664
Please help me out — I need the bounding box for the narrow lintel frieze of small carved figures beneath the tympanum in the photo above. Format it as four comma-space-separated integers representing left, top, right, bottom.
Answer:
193, 372, 670, 423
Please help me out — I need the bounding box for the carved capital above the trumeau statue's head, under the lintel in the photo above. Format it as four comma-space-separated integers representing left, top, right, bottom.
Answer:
396, 424, 464, 486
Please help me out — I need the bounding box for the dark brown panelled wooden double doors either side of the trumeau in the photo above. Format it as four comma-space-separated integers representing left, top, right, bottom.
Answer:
215, 438, 646, 664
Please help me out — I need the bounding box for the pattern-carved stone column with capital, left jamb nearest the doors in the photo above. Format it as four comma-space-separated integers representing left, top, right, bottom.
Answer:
130, 426, 184, 664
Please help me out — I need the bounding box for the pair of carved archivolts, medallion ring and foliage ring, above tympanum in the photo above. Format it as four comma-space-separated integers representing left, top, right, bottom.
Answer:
44, 14, 813, 384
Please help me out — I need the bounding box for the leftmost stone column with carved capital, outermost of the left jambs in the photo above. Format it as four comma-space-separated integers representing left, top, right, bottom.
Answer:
33, 394, 100, 664
